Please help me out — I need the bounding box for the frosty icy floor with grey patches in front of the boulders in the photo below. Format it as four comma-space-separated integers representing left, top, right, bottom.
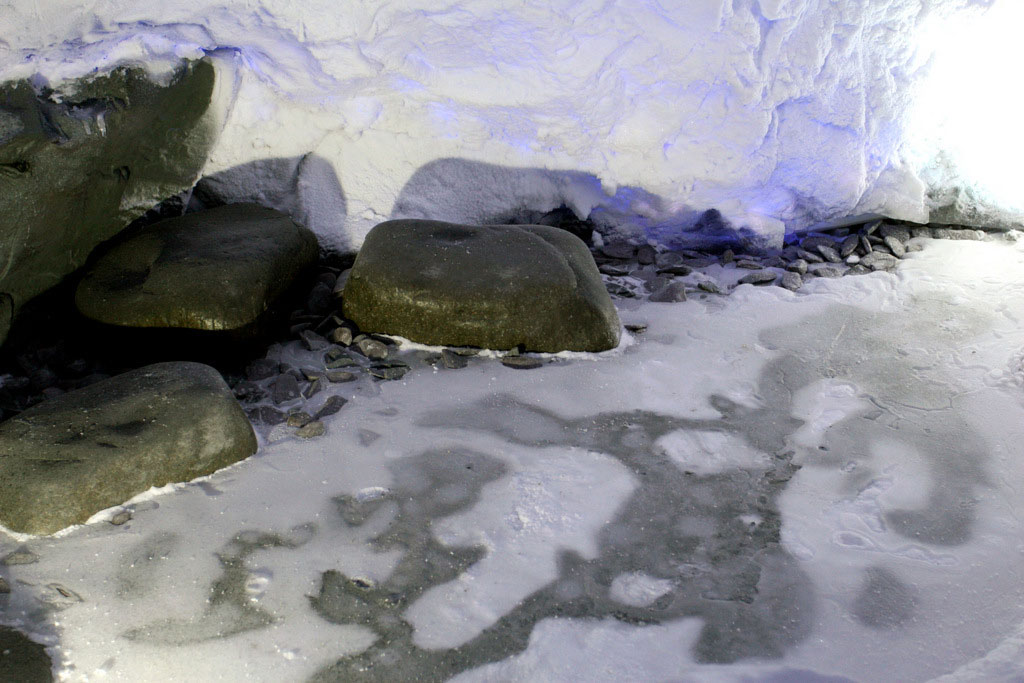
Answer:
0, 237, 1024, 682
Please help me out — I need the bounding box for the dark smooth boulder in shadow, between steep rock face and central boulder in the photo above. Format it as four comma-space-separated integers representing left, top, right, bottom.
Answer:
75, 204, 318, 331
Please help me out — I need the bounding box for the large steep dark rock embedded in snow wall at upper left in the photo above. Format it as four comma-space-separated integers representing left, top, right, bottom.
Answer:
0, 60, 222, 342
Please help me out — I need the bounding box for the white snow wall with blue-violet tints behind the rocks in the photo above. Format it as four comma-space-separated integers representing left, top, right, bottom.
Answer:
0, 0, 1024, 249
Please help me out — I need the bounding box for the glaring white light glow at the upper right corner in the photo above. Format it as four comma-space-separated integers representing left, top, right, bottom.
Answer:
907, 0, 1024, 210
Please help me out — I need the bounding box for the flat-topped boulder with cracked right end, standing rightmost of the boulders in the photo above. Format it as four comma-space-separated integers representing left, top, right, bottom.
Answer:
343, 220, 620, 352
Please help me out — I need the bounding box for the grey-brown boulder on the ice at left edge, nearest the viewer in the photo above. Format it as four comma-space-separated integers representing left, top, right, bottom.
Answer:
0, 362, 256, 535
